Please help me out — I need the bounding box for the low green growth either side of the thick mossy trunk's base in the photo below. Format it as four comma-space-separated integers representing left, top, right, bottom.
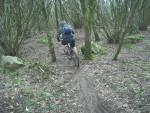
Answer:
80, 42, 107, 60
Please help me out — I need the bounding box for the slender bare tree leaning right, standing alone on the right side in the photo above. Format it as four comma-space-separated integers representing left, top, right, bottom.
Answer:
113, 0, 143, 60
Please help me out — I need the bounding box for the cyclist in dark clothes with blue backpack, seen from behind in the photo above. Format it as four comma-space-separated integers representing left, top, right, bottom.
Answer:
57, 21, 77, 52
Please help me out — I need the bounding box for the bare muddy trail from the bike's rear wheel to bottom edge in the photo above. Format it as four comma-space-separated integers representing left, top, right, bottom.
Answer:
72, 65, 110, 113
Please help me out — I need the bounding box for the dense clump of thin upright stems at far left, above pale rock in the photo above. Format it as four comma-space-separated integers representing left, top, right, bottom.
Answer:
0, 0, 36, 55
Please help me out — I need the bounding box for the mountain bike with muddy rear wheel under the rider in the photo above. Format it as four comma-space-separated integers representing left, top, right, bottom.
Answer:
64, 43, 80, 67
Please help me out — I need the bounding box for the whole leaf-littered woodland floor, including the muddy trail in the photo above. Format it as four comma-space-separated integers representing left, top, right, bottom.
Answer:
0, 29, 150, 113
